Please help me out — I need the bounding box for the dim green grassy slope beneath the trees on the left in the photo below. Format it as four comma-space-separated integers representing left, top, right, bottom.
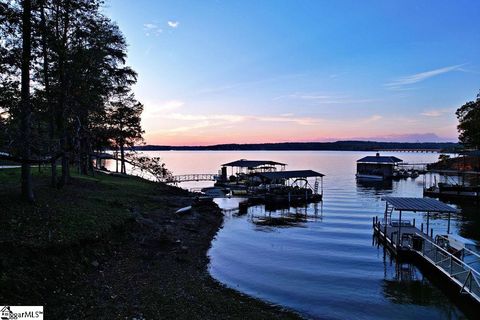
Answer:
0, 169, 156, 248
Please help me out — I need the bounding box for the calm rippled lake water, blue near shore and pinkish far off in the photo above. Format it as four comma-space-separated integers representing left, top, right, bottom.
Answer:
109, 151, 480, 319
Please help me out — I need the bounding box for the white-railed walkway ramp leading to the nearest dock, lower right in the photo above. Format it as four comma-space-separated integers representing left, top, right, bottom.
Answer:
415, 234, 480, 302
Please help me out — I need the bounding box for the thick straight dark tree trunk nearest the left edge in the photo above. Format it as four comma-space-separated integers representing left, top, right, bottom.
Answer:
20, 0, 34, 202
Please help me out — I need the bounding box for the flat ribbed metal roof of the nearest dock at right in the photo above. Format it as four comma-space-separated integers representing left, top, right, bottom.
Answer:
382, 197, 457, 213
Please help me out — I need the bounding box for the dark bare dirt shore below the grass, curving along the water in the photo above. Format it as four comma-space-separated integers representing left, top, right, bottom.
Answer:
0, 174, 300, 319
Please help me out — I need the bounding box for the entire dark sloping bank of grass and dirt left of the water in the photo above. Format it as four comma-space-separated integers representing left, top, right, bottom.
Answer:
0, 169, 297, 319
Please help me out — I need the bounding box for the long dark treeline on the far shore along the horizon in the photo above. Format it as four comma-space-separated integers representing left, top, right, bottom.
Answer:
135, 141, 460, 152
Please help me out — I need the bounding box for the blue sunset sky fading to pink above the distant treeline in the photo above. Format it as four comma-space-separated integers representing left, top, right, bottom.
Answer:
105, 0, 480, 145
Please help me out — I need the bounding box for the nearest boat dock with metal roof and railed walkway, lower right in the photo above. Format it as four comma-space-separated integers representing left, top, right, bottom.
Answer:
373, 197, 480, 306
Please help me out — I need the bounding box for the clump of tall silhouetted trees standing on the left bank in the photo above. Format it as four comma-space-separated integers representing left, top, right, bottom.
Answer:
0, 0, 143, 199
